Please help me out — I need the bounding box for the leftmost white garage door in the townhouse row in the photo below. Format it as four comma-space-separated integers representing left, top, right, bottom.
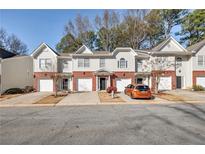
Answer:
39, 79, 53, 92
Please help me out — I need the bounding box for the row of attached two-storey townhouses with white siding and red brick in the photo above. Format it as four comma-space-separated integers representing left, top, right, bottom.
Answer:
0, 37, 205, 91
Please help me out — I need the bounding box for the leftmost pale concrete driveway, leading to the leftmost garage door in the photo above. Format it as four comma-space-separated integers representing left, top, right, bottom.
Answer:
0, 92, 51, 106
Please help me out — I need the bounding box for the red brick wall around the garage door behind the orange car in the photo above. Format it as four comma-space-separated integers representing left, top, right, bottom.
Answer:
111, 72, 135, 87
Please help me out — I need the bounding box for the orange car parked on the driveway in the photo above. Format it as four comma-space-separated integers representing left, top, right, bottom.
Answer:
124, 84, 152, 99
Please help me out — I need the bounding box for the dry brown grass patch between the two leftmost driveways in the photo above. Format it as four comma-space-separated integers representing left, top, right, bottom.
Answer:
34, 95, 65, 104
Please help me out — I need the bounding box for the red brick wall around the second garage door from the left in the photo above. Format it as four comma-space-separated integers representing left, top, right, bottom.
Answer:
73, 71, 96, 91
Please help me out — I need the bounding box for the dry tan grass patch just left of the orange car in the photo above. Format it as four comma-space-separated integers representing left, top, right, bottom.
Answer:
98, 92, 125, 103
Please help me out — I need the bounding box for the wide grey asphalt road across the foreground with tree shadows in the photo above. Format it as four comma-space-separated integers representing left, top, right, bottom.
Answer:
0, 103, 205, 144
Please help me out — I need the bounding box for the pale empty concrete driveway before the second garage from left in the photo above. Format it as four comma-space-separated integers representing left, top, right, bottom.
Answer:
56, 91, 100, 106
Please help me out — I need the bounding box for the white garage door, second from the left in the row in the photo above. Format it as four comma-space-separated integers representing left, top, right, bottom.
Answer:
78, 79, 92, 91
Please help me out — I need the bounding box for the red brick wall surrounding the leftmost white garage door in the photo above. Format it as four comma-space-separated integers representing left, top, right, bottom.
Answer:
33, 72, 56, 91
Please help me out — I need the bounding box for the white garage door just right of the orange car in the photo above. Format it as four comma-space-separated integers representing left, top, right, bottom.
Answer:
159, 76, 172, 90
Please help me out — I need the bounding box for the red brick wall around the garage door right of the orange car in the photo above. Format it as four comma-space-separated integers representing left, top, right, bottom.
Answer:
151, 71, 176, 91
